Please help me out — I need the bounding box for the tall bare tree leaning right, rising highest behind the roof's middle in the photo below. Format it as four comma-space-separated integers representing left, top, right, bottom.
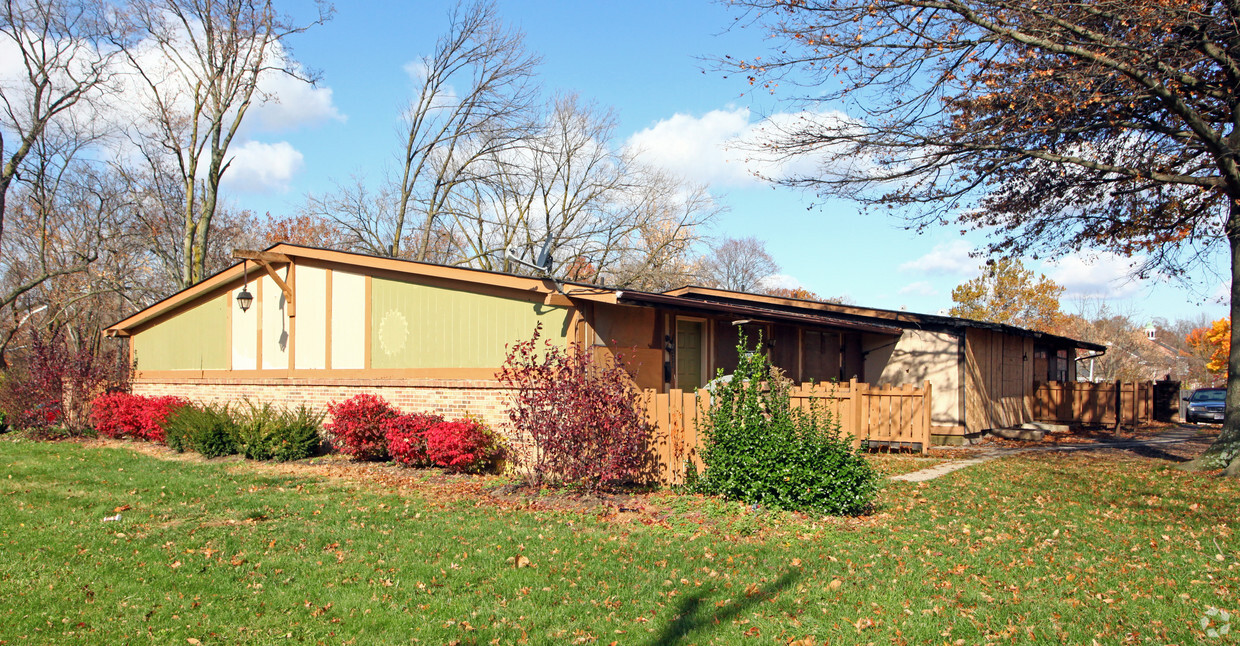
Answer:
386, 1, 538, 260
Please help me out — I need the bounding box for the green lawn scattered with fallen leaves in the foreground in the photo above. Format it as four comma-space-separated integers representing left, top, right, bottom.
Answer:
0, 441, 1240, 645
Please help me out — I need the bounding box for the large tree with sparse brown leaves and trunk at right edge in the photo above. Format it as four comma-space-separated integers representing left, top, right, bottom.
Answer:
725, 0, 1240, 475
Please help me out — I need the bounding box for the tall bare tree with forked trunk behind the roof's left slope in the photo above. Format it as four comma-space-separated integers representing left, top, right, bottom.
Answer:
124, 0, 331, 288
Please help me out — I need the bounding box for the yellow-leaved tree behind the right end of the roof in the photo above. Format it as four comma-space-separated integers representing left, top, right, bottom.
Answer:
950, 258, 1064, 332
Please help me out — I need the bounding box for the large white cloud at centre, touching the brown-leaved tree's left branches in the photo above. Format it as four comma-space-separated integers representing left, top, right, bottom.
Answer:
626, 108, 844, 186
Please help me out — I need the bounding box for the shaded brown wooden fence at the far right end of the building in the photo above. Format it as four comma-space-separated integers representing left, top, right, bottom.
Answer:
1029, 382, 1154, 427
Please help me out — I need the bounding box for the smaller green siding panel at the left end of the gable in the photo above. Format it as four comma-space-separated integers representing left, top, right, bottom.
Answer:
133, 295, 231, 371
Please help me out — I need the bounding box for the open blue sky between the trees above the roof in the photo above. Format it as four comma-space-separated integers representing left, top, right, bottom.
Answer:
226, 0, 1226, 320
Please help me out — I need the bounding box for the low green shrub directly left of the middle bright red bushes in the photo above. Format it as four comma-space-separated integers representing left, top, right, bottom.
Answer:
236, 400, 322, 462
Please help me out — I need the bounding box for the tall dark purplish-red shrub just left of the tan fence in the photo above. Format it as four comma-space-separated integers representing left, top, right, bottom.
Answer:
498, 325, 651, 490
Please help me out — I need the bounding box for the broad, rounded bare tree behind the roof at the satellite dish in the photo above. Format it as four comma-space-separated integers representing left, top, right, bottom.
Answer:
450, 95, 719, 286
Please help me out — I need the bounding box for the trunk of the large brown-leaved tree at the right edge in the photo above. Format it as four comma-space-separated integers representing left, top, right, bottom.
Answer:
1180, 196, 1240, 477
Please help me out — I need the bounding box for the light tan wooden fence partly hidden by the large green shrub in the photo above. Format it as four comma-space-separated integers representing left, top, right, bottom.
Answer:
642, 379, 930, 485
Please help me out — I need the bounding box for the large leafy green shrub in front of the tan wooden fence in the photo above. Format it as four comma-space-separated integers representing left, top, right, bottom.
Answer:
694, 336, 878, 516
